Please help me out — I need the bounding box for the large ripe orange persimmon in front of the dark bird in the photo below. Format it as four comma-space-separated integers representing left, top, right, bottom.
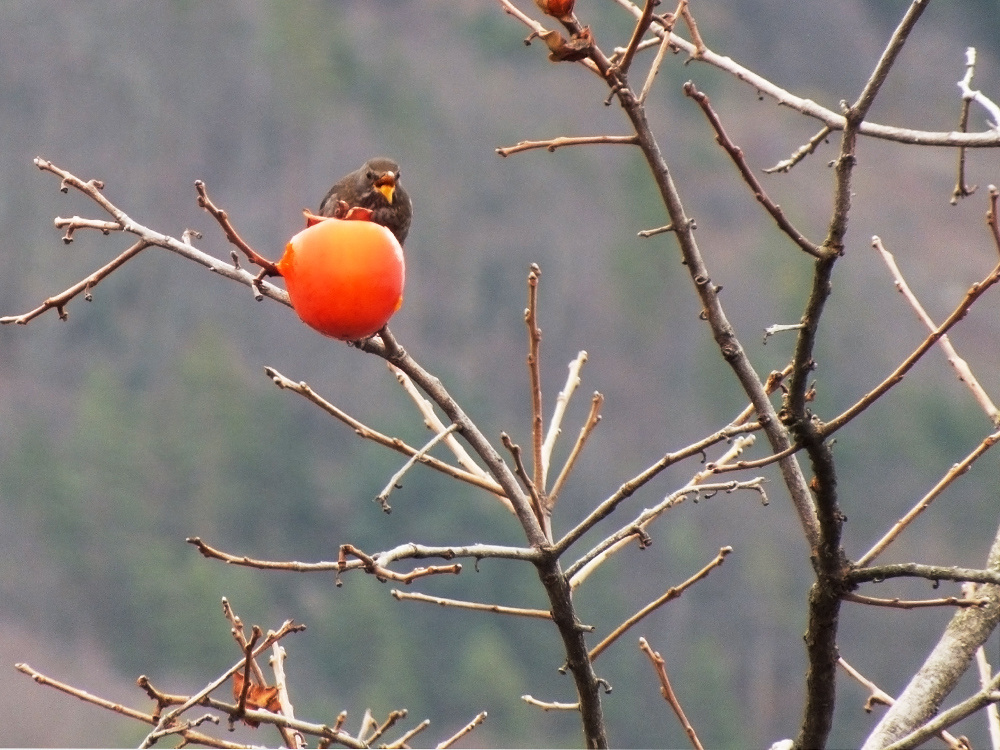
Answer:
277, 214, 405, 341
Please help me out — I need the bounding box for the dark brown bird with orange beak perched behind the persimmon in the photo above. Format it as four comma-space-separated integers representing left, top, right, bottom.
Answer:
319, 156, 413, 245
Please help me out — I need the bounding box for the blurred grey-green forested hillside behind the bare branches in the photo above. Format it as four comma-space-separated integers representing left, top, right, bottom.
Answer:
0, 0, 1000, 748
